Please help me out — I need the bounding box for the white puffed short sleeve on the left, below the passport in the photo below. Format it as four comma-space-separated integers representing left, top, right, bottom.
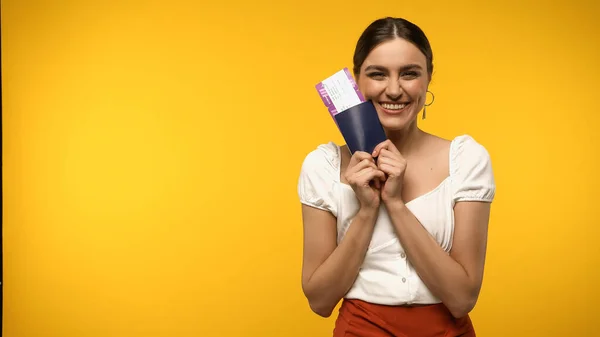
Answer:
298, 143, 339, 216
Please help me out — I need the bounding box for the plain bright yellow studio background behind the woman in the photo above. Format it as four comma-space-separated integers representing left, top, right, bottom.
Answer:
2, 0, 600, 337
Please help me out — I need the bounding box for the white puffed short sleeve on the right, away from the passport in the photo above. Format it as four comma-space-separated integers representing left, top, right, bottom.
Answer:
450, 135, 496, 202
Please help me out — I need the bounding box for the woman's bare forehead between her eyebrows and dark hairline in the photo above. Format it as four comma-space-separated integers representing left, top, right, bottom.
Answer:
363, 38, 427, 68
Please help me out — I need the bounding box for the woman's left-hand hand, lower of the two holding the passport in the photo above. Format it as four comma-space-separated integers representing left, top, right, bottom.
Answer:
344, 151, 385, 210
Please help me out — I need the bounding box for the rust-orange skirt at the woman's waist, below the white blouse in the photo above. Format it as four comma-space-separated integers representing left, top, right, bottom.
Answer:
333, 299, 475, 337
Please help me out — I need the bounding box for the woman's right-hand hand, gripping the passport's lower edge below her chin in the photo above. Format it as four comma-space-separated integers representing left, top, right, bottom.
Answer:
373, 139, 406, 203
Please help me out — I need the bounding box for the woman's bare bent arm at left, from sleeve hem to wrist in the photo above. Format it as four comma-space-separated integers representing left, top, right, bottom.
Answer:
302, 205, 377, 317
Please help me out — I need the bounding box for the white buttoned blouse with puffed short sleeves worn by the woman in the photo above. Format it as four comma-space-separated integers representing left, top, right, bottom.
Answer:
298, 135, 496, 305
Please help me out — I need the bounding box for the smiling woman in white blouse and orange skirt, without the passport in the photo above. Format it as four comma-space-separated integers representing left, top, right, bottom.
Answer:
298, 18, 495, 337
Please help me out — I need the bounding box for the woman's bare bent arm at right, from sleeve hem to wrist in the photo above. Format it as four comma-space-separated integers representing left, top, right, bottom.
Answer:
386, 201, 490, 318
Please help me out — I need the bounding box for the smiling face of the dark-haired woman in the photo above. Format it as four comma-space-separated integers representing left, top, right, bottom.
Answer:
357, 38, 429, 130
